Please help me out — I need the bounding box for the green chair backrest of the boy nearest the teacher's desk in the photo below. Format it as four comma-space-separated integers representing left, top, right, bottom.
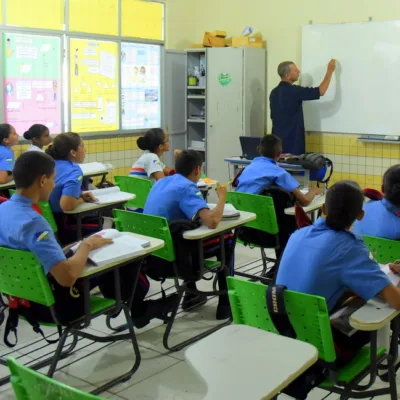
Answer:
227, 192, 279, 235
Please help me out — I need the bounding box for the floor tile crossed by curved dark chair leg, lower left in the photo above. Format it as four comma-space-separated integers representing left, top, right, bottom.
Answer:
62, 342, 179, 393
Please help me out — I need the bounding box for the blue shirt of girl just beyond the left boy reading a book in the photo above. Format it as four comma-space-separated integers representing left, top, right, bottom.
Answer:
49, 160, 83, 213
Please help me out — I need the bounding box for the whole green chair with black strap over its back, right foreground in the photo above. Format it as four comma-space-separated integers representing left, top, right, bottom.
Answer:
228, 277, 397, 399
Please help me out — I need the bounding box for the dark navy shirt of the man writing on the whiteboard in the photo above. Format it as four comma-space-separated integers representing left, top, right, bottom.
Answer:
269, 82, 320, 155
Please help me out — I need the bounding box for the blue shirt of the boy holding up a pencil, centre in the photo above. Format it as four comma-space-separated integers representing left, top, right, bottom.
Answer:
143, 174, 208, 221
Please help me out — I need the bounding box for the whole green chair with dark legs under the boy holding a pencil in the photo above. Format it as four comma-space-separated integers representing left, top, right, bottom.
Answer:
112, 210, 231, 351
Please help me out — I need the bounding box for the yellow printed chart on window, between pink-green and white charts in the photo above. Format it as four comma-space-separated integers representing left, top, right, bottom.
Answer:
70, 39, 119, 132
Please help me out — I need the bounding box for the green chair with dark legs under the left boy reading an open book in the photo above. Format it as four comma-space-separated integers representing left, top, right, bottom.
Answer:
0, 247, 140, 393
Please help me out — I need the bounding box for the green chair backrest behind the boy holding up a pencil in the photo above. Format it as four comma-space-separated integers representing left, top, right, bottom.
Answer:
113, 210, 175, 262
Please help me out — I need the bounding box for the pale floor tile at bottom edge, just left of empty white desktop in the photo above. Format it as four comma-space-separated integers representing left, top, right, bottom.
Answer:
118, 362, 208, 400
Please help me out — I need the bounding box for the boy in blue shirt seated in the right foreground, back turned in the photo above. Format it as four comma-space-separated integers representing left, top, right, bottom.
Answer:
276, 181, 400, 364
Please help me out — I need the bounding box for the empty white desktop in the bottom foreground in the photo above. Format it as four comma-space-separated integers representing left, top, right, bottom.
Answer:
185, 325, 318, 400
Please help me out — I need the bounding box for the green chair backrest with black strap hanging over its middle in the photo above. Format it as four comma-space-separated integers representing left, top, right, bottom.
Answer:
228, 277, 336, 362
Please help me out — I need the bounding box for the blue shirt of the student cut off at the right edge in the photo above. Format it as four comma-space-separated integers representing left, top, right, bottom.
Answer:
353, 198, 400, 240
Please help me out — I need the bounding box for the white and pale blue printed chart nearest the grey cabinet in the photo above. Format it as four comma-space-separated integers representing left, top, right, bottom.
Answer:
121, 43, 161, 129
